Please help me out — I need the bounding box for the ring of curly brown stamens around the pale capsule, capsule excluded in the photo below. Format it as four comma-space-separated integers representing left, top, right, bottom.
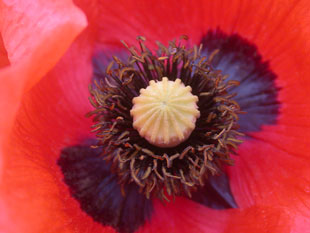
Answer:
88, 37, 242, 199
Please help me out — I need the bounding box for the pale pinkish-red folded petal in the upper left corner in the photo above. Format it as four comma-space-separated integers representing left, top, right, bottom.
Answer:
0, 0, 86, 144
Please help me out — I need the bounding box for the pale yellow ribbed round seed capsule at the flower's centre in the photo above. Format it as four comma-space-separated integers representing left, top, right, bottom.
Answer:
130, 77, 200, 147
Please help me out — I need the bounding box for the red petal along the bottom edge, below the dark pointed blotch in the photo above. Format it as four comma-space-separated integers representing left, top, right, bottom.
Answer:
138, 198, 294, 233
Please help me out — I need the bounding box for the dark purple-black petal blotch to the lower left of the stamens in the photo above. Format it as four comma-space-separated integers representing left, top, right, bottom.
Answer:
58, 146, 153, 233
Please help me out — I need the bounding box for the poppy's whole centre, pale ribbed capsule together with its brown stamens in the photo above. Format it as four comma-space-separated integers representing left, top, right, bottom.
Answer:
88, 37, 242, 199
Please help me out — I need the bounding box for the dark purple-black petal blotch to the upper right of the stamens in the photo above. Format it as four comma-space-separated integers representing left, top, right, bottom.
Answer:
201, 29, 280, 133
